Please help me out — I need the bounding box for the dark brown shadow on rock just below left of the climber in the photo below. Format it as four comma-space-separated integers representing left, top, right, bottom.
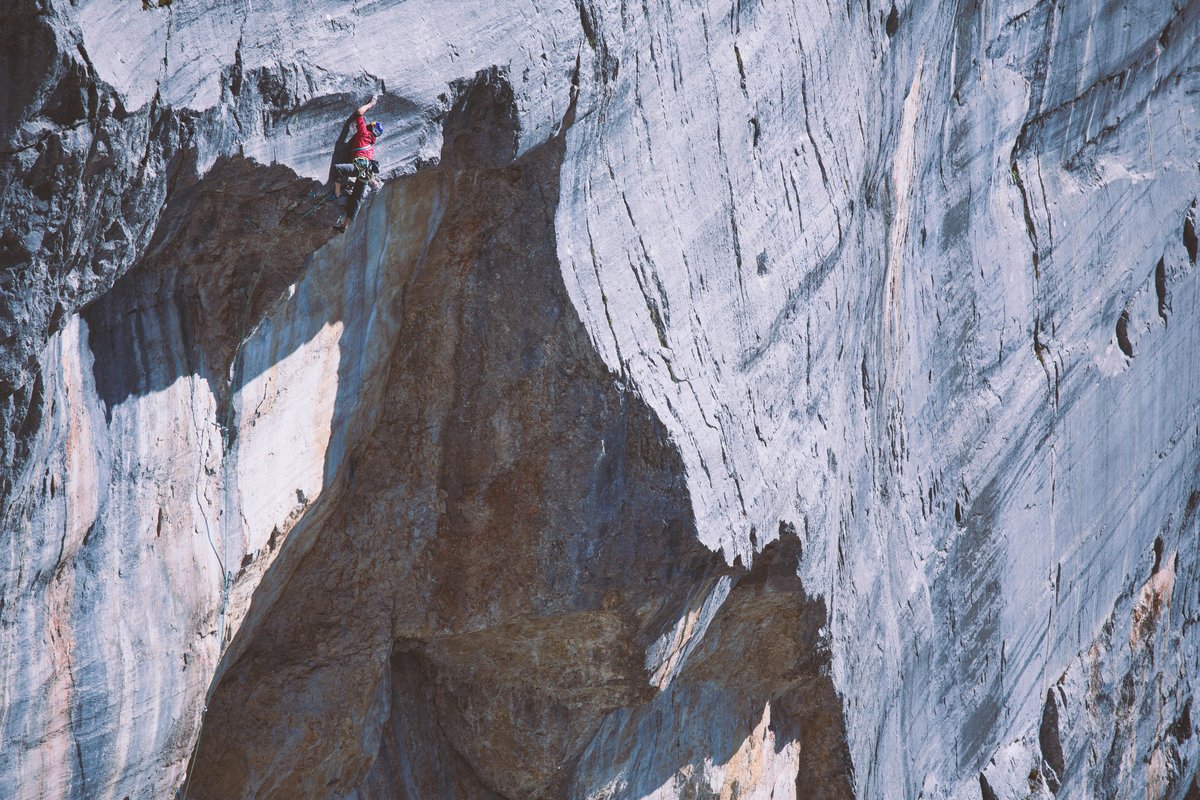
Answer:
84, 158, 337, 443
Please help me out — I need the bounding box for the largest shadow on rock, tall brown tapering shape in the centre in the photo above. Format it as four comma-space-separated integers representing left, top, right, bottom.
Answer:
188, 71, 848, 800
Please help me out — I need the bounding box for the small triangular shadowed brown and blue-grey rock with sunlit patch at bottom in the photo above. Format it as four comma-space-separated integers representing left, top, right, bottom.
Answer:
566, 531, 854, 800
